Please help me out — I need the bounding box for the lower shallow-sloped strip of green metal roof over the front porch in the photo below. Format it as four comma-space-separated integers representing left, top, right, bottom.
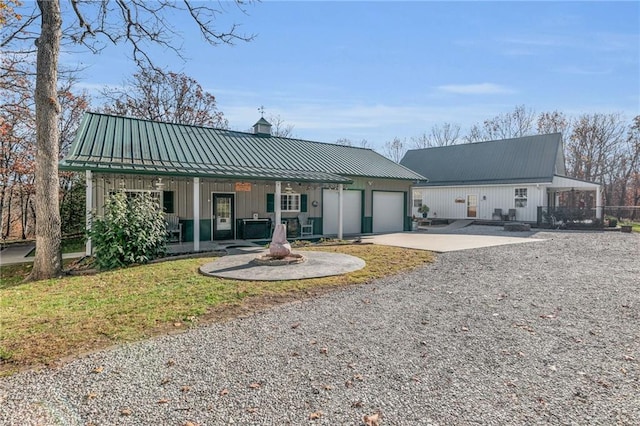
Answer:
60, 159, 353, 183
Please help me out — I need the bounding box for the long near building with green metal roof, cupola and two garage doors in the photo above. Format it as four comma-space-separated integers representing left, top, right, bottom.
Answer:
60, 113, 424, 253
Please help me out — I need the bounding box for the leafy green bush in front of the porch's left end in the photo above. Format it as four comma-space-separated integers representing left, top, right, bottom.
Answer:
89, 191, 167, 270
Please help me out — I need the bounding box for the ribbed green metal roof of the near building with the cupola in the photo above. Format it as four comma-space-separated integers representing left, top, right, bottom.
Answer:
60, 113, 423, 183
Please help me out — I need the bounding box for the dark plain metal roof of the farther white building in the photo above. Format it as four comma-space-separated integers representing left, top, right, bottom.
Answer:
400, 133, 565, 186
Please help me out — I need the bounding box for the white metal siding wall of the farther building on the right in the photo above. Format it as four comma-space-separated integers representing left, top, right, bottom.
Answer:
411, 184, 546, 222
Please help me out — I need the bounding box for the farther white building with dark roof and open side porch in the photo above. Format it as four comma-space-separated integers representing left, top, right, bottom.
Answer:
400, 133, 602, 223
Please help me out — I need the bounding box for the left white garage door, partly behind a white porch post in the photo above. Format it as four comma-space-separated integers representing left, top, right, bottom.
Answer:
322, 189, 362, 235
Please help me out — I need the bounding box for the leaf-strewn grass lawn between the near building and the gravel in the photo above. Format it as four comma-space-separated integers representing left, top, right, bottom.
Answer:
0, 245, 433, 375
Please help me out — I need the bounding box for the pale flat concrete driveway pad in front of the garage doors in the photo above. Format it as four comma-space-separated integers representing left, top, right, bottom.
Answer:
362, 232, 544, 253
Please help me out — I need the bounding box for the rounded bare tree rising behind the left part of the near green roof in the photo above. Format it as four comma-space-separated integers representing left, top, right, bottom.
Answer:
102, 68, 229, 129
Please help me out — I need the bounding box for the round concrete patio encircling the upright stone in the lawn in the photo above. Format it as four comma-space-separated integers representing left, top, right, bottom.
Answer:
200, 250, 366, 281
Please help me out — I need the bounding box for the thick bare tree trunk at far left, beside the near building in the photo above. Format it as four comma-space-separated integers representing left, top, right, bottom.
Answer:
29, 0, 62, 280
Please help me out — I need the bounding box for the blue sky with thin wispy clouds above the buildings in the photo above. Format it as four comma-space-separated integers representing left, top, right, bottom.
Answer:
51, 0, 640, 150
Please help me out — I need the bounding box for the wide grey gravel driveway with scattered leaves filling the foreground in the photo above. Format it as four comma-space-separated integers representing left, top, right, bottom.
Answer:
0, 231, 640, 426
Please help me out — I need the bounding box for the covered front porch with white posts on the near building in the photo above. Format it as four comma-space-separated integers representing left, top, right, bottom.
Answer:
85, 171, 353, 255
